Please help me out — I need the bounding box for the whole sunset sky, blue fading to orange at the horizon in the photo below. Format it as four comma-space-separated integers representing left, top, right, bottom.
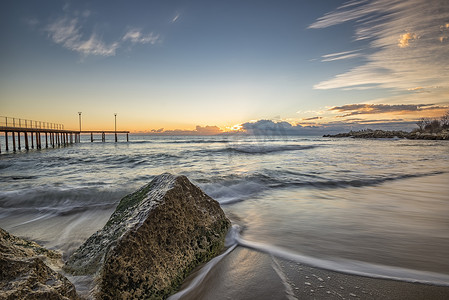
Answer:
0, 0, 449, 134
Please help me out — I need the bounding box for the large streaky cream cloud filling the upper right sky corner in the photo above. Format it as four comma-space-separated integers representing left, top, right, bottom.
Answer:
309, 0, 449, 103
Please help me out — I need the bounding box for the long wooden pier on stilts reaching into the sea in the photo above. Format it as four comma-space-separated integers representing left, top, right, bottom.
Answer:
0, 117, 129, 153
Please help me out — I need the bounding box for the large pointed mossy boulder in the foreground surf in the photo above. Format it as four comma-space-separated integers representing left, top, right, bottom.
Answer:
65, 173, 230, 299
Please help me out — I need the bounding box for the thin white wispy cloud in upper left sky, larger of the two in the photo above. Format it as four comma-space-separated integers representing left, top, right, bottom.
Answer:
45, 17, 120, 56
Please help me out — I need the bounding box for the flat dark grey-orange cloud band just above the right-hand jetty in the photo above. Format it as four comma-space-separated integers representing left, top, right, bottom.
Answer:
329, 104, 449, 117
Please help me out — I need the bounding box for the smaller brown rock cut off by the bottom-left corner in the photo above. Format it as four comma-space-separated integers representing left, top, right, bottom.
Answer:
0, 228, 78, 299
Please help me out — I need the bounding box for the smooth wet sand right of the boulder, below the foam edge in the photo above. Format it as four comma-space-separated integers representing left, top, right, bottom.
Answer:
173, 246, 449, 300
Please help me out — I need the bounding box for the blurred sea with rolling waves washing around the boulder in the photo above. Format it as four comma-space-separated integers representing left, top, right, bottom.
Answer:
0, 134, 449, 285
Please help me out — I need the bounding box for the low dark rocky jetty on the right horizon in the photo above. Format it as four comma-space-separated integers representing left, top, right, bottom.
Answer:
323, 129, 449, 140
